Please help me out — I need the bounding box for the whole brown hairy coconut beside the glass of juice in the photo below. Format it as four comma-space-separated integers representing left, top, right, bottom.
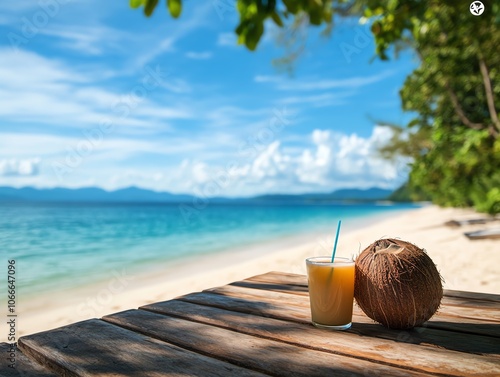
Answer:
354, 238, 443, 329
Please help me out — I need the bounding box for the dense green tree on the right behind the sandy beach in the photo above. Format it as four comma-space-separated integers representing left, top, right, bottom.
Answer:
372, 1, 500, 214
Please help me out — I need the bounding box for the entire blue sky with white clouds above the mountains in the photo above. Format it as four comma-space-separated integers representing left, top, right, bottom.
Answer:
0, 0, 417, 196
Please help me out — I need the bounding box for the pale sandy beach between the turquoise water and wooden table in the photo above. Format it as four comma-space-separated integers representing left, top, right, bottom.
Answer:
7, 206, 500, 342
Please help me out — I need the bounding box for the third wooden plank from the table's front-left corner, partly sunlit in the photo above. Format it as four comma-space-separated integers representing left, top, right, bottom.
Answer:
139, 300, 500, 376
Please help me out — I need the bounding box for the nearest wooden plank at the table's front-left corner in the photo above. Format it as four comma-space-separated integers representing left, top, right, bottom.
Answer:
19, 319, 262, 377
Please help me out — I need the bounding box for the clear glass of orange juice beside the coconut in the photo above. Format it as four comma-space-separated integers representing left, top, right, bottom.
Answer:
306, 257, 354, 330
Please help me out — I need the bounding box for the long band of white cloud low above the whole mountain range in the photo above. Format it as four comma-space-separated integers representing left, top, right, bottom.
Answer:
0, 127, 408, 196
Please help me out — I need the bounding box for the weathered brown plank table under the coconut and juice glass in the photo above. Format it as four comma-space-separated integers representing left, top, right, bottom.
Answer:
0, 272, 500, 377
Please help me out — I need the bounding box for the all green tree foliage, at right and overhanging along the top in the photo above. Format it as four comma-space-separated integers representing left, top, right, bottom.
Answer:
130, 0, 500, 214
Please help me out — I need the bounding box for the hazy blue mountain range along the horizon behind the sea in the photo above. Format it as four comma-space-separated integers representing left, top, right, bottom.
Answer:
0, 187, 392, 203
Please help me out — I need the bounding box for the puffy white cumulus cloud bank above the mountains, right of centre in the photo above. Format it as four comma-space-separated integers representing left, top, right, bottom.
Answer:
154, 126, 408, 196
